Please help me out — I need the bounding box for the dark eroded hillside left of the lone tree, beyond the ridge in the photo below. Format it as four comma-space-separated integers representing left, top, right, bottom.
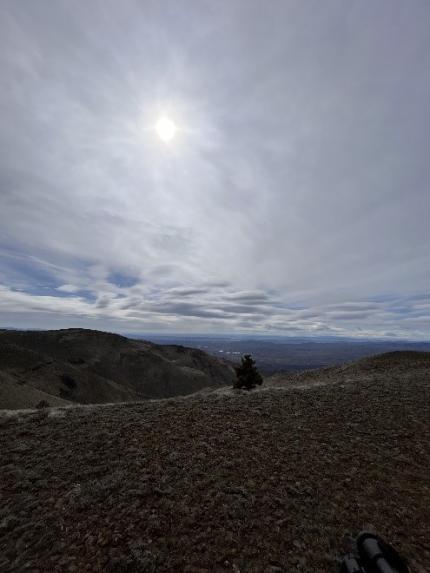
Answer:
0, 329, 234, 409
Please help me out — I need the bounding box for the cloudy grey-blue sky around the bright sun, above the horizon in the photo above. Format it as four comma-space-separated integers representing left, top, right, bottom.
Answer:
0, 0, 430, 339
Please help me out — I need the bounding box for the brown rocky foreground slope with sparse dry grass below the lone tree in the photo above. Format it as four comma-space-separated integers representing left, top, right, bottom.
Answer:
0, 358, 430, 573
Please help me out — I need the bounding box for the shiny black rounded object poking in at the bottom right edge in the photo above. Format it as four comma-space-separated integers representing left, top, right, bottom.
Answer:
340, 531, 409, 573
